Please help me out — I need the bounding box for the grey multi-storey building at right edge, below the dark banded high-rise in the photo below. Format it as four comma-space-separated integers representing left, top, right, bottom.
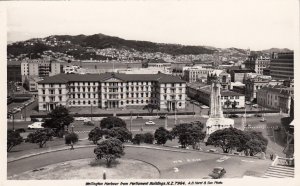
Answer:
257, 85, 294, 113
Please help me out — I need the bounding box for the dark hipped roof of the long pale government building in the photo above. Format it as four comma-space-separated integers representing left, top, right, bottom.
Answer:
39, 73, 185, 84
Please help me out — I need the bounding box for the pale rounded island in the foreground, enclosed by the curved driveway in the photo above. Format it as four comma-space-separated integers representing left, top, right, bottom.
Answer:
8, 158, 160, 180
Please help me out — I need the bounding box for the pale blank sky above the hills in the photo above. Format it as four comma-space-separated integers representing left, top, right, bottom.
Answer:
7, 0, 299, 50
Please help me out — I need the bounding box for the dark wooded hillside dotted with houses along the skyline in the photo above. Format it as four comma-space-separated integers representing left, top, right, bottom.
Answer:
7, 34, 215, 56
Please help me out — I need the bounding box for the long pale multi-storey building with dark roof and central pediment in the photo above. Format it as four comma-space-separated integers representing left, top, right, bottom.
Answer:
38, 73, 186, 110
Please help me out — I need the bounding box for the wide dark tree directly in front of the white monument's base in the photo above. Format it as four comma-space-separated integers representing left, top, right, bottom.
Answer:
206, 127, 250, 153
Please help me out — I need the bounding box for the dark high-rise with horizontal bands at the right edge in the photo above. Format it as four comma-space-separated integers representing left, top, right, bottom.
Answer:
270, 52, 294, 80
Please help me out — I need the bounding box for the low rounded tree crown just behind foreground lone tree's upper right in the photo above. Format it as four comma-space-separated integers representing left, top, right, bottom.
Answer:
106, 127, 132, 142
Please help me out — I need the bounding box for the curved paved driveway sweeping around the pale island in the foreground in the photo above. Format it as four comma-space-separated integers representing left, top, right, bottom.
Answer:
7, 146, 271, 179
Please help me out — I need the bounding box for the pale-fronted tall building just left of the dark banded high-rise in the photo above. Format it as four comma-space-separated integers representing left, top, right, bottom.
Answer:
245, 56, 270, 75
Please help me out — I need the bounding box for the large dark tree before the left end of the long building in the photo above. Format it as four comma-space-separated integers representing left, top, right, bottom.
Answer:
43, 106, 74, 137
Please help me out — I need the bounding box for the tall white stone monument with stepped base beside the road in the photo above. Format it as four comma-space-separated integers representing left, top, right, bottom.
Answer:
205, 79, 234, 136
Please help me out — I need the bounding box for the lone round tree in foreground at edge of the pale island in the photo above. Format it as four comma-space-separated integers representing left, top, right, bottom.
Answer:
94, 138, 125, 167
